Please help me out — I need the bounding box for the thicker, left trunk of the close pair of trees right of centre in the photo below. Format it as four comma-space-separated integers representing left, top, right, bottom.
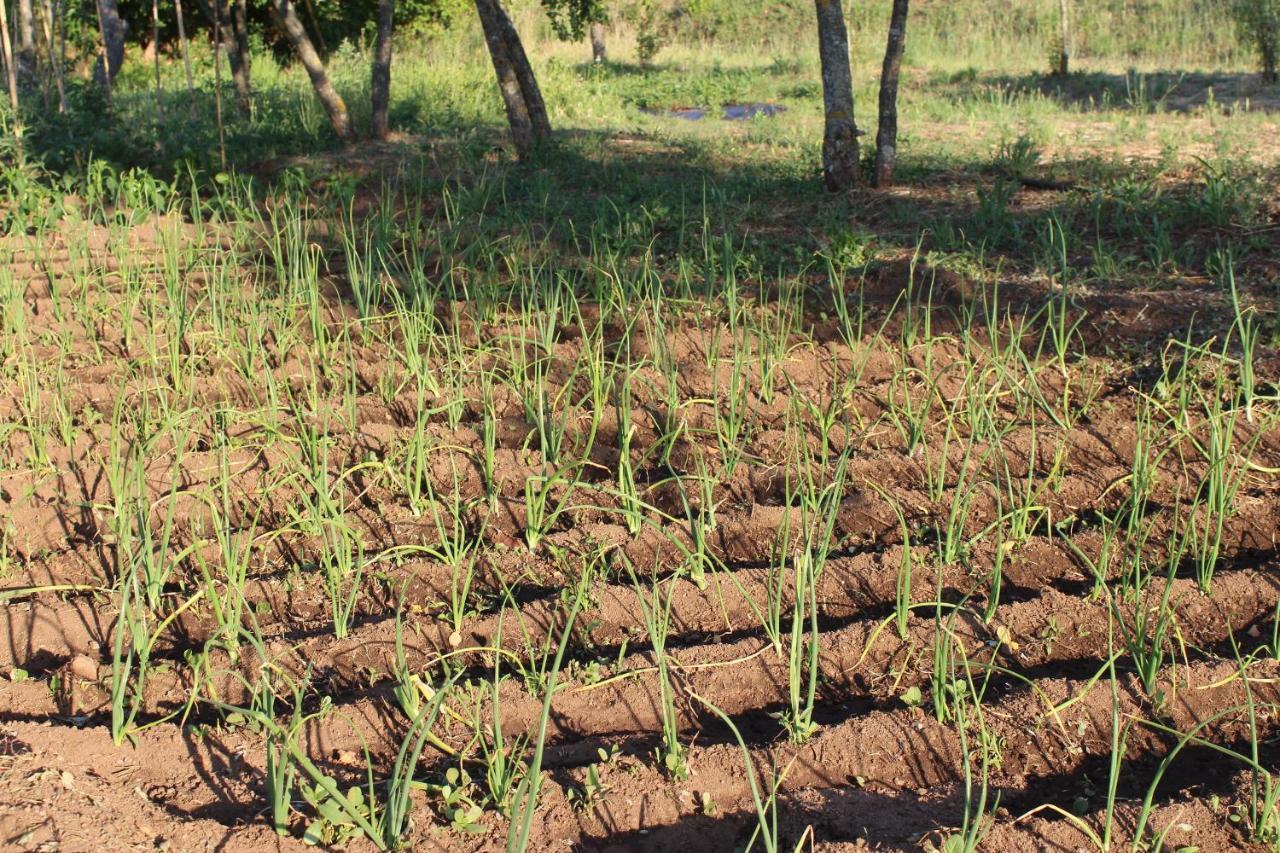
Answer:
815, 0, 859, 192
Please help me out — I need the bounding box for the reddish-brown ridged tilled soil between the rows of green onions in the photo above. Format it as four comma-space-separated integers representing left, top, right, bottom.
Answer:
0, 207, 1280, 850
